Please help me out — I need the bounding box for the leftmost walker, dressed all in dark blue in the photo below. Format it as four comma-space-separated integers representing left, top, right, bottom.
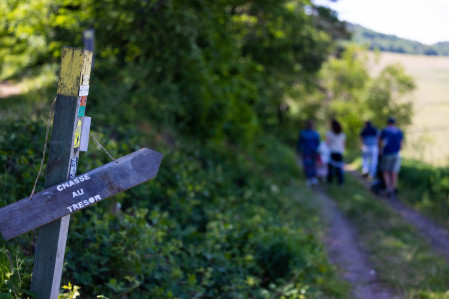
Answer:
296, 120, 320, 186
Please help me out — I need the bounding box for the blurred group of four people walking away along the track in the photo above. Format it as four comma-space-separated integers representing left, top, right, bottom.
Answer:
296, 117, 403, 196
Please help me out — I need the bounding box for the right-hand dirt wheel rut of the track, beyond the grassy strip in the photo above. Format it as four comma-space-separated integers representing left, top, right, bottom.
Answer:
348, 170, 449, 261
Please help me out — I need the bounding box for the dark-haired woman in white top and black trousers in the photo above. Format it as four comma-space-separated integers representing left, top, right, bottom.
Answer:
326, 119, 346, 185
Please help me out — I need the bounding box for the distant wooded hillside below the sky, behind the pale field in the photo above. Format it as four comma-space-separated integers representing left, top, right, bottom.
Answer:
348, 23, 449, 56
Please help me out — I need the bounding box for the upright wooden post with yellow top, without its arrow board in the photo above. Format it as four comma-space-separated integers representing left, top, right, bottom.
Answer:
31, 47, 92, 299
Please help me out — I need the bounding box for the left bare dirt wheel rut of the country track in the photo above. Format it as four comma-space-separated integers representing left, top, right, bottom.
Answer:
316, 189, 398, 299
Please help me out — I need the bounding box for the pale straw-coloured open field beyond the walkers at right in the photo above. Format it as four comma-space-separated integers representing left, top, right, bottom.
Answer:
370, 52, 449, 165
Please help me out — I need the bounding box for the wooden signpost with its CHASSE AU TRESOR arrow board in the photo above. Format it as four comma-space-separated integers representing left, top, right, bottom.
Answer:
0, 47, 162, 299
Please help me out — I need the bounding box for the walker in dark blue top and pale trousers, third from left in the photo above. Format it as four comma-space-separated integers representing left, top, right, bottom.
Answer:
360, 121, 379, 179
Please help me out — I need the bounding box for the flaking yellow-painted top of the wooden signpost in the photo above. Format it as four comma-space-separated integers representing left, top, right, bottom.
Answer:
57, 47, 92, 97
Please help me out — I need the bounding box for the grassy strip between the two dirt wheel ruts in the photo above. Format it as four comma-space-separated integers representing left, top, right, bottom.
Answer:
327, 175, 449, 298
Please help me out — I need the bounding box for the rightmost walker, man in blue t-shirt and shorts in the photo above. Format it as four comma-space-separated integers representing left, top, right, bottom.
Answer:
379, 117, 404, 197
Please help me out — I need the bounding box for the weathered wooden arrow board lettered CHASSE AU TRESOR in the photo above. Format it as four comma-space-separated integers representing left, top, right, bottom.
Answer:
0, 148, 162, 240
